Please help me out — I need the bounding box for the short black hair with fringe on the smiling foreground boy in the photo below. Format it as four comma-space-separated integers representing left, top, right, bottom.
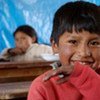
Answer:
51, 1, 100, 43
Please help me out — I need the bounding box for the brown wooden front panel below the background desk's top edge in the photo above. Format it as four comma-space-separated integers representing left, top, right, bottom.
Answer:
0, 66, 51, 83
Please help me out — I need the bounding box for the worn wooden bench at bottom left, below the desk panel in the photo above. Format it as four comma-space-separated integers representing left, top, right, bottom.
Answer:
0, 81, 31, 100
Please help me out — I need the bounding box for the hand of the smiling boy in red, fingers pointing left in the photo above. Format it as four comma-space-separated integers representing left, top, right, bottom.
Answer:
43, 65, 73, 84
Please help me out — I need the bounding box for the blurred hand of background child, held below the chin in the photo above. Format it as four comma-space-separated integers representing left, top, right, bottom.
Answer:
8, 48, 25, 56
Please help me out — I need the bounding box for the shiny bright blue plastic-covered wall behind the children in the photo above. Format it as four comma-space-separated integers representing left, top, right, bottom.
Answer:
0, 0, 100, 51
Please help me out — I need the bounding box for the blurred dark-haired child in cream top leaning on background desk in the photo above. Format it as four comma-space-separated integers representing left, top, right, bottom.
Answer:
1, 25, 53, 61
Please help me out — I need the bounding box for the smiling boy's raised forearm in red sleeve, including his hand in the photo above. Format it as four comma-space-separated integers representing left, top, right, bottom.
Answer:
43, 63, 100, 100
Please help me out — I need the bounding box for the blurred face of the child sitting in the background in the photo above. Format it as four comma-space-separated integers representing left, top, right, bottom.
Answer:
15, 32, 33, 52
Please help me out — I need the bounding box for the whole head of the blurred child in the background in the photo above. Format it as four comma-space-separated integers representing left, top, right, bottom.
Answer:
14, 25, 37, 51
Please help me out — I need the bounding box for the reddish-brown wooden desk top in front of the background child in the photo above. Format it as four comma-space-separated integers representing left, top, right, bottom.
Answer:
0, 61, 54, 69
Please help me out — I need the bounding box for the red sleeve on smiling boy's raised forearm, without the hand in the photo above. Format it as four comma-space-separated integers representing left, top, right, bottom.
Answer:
69, 64, 100, 100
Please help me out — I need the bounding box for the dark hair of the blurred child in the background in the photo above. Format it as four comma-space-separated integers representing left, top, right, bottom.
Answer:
13, 25, 37, 43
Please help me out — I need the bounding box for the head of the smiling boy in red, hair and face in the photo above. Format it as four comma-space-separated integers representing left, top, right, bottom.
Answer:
51, 1, 100, 68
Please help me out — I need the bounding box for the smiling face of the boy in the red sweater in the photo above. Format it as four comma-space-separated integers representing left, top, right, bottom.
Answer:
52, 31, 100, 69
